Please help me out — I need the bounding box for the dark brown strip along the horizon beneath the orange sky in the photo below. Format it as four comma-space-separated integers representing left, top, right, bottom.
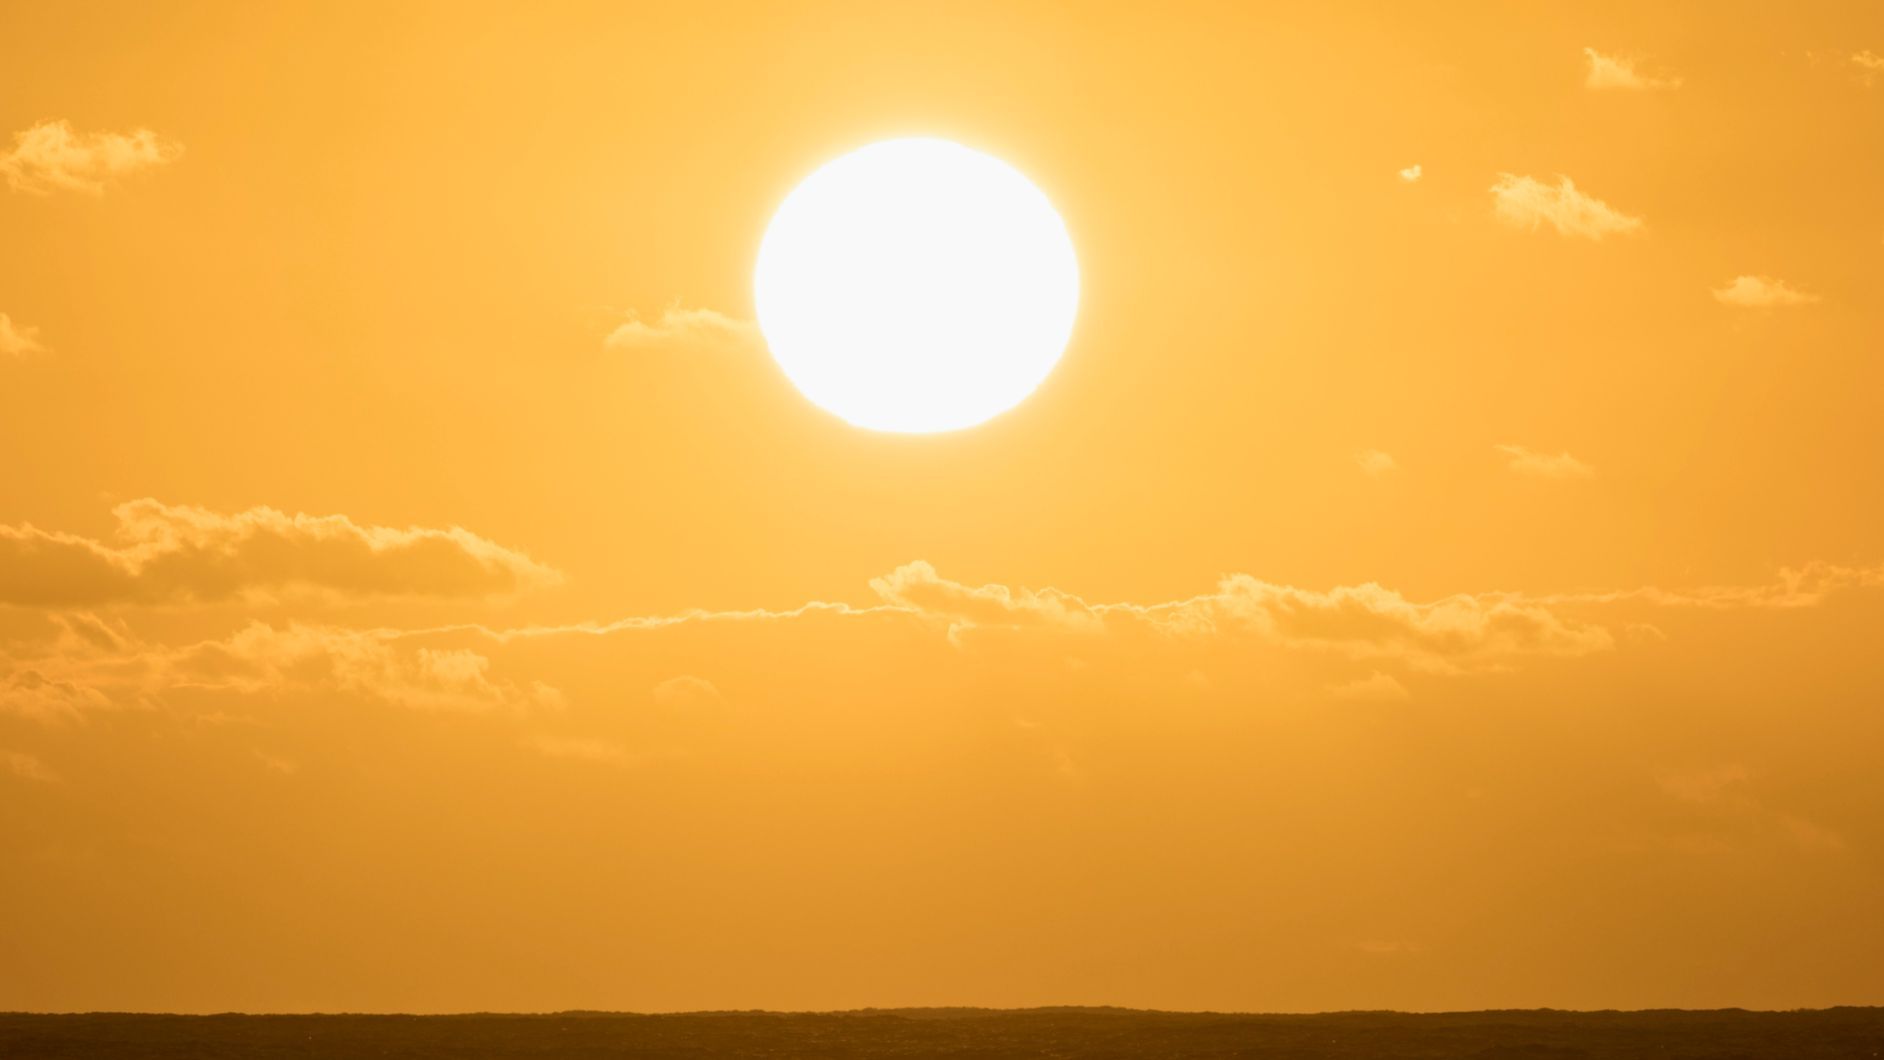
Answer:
0, 1007, 1884, 1060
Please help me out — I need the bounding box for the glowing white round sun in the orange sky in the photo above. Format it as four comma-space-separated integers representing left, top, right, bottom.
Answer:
754, 137, 1080, 433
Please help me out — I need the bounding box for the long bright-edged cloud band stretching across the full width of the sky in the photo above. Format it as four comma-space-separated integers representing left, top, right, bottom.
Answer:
14, 561, 1884, 722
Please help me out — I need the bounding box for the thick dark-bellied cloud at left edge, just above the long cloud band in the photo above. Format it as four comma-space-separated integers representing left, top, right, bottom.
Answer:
0, 497, 561, 606
